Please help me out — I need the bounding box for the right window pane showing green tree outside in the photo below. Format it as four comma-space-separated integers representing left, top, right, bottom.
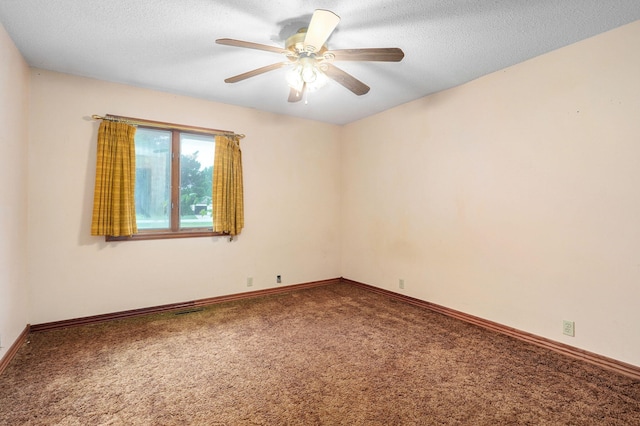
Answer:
180, 133, 215, 228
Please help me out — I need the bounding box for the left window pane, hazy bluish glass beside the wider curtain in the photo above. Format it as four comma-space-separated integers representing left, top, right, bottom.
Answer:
135, 127, 171, 229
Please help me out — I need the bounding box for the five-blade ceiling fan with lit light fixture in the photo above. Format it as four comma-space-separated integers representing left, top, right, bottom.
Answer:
216, 9, 404, 102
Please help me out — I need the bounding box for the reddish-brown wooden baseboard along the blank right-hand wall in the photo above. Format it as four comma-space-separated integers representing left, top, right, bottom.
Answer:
342, 278, 640, 380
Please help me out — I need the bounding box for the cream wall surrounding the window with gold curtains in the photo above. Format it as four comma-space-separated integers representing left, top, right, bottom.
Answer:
28, 69, 340, 324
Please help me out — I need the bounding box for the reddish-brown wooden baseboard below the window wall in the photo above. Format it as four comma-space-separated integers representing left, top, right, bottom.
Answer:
31, 278, 340, 333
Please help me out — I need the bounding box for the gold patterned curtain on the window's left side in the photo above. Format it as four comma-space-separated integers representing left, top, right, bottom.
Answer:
91, 120, 138, 237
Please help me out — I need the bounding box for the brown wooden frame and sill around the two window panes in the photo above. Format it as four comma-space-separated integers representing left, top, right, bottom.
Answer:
105, 115, 238, 241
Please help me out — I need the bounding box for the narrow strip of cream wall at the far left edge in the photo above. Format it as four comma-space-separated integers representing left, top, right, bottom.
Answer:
0, 21, 29, 359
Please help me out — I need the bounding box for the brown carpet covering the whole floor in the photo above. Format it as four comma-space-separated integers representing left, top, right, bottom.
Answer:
0, 284, 640, 425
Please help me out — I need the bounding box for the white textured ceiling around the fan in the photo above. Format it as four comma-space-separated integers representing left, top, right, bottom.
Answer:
0, 0, 640, 124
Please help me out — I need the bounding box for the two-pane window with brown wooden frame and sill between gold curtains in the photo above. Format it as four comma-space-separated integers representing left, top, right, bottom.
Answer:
107, 121, 226, 241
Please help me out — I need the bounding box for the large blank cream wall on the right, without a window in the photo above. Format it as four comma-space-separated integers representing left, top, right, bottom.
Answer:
341, 22, 640, 365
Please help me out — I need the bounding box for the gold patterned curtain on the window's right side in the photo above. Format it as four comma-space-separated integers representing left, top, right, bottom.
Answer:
213, 135, 244, 235
